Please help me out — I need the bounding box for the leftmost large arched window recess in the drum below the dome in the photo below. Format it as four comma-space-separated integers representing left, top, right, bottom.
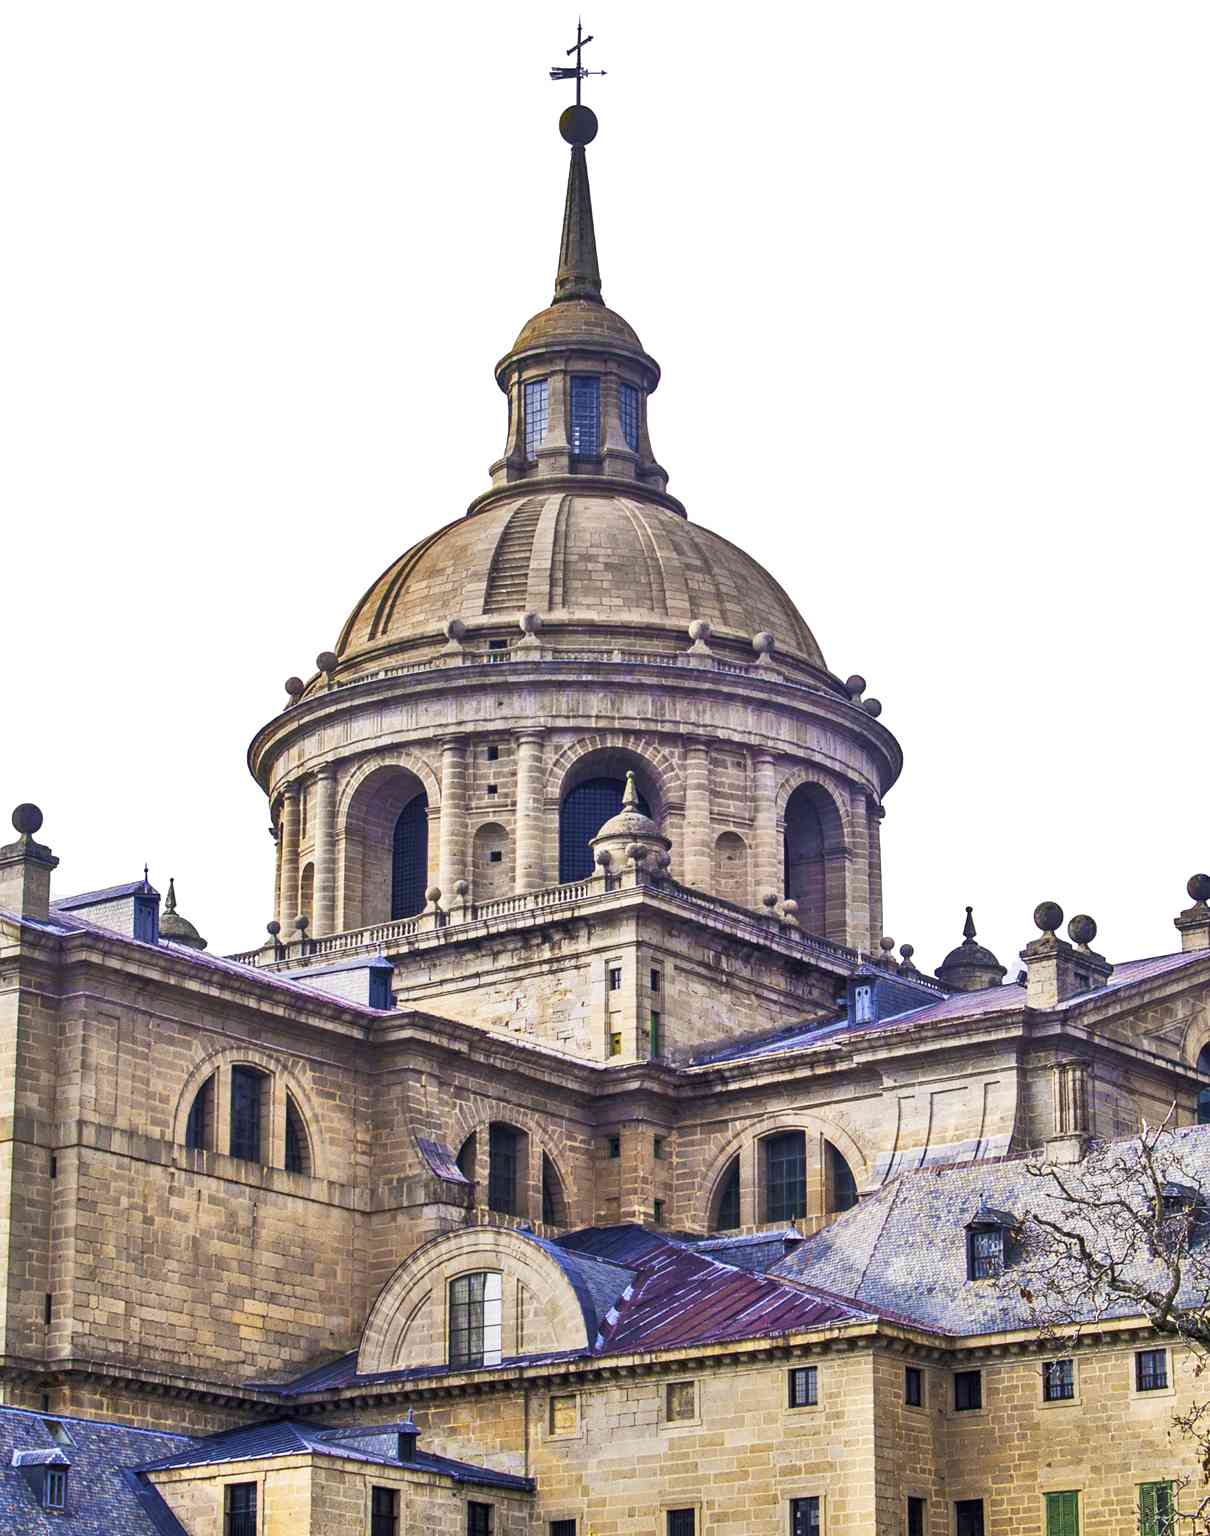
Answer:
338, 763, 436, 929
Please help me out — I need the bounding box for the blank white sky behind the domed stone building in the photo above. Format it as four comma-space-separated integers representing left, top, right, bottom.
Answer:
0, 0, 1210, 974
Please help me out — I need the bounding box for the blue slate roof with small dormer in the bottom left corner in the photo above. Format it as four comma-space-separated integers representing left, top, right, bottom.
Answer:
0, 1407, 192, 1536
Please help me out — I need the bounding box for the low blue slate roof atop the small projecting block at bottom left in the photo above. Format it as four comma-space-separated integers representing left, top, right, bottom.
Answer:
140, 1419, 533, 1493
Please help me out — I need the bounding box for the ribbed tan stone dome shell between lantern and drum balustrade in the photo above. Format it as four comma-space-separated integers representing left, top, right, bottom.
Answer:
336, 488, 826, 670
